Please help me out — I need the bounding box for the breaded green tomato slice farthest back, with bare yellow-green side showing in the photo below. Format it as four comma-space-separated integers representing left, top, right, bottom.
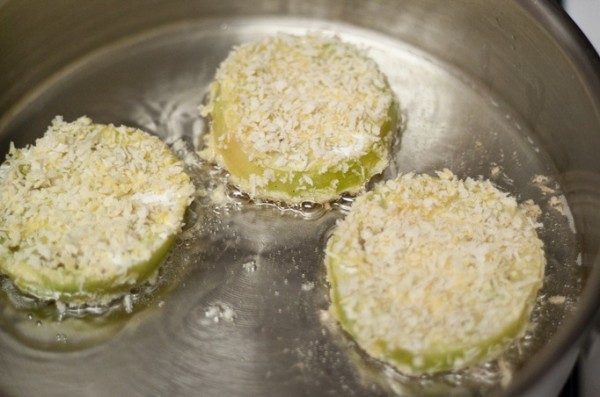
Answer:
201, 34, 398, 203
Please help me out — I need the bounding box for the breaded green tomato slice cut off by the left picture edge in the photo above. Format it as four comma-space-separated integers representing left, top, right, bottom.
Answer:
0, 116, 194, 304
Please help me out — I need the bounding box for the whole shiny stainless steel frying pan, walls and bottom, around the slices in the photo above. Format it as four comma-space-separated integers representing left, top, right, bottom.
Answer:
0, 0, 600, 396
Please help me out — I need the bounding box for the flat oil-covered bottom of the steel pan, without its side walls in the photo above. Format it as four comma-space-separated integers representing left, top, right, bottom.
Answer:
0, 17, 586, 396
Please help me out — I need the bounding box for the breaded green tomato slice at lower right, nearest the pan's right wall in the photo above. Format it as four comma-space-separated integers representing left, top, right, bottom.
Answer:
325, 170, 545, 375
